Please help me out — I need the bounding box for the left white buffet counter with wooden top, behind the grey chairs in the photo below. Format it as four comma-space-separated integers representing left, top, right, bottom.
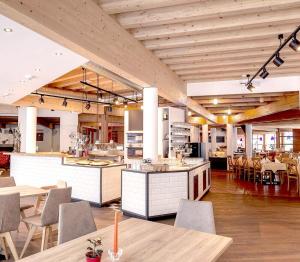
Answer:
10, 153, 126, 206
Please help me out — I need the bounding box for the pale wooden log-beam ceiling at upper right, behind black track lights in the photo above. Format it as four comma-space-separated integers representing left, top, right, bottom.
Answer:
95, 0, 300, 81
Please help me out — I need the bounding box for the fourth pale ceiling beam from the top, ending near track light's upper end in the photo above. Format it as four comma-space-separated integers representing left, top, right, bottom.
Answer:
143, 23, 299, 50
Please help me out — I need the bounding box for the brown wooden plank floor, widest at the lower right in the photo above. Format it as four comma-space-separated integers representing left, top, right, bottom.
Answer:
5, 172, 300, 262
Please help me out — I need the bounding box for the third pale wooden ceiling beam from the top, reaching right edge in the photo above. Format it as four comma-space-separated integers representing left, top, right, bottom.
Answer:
131, 6, 300, 40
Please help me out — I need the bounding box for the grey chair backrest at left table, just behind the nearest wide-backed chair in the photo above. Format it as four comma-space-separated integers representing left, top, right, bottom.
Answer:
41, 187, 72, 226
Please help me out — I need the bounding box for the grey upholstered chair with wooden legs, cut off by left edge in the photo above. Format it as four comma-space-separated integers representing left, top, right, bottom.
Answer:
0, 193, 20, 260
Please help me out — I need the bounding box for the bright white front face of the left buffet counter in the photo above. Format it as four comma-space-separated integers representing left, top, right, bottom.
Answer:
11, 155, 100, 203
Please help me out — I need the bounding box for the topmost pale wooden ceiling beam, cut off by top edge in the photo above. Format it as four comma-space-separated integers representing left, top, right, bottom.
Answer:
95, 0, 199, 14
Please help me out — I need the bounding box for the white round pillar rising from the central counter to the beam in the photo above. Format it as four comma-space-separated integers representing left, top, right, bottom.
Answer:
143, 87, 158, 161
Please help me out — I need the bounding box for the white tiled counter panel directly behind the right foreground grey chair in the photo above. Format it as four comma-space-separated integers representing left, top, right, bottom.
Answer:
149, 172, 188, 216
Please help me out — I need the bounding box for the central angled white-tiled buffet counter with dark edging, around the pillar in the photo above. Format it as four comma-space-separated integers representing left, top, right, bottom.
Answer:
122, 161, 211, 219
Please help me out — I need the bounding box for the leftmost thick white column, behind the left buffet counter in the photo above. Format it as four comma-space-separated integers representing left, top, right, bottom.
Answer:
18, 107, 37, 153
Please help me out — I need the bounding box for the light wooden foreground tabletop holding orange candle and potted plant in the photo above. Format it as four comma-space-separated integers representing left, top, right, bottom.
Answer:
19, 218, 232, 262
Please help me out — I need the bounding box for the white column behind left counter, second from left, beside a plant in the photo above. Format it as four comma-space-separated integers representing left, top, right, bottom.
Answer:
60, 112, 78, 151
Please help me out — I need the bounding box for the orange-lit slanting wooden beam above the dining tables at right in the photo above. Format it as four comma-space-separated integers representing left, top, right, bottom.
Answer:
232, 95, 299, 123
